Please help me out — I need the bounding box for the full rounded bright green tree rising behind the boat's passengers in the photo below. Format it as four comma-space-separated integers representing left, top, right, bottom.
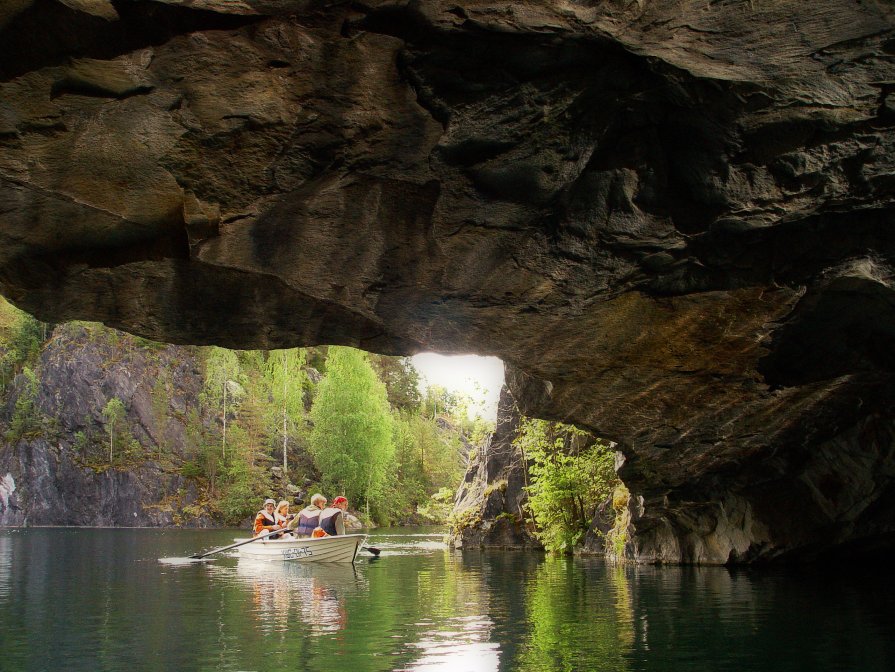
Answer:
309, 347, 395, 507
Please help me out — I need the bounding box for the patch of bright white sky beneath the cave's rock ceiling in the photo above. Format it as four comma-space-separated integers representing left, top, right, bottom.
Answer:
411, 352, 503, 420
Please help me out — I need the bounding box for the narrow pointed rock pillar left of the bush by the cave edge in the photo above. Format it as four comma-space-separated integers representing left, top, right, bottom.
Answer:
451, 387, 541, 548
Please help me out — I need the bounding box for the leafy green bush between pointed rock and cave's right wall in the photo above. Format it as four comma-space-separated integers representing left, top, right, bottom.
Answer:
514, 419, 618, 553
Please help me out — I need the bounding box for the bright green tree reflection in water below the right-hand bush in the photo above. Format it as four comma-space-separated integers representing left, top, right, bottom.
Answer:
517, 557, 634, 672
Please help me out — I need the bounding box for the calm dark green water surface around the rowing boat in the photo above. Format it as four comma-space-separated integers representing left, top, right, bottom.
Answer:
0, 529, 895, 672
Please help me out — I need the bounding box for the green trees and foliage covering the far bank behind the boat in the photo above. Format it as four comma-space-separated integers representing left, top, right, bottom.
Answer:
0, 299, 480, 523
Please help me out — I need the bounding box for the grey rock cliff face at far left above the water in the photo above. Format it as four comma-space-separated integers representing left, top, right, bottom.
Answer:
0, 325, 212, 527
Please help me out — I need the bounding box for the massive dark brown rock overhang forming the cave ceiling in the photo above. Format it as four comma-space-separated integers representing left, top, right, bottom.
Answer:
0, 0, 895, 562
